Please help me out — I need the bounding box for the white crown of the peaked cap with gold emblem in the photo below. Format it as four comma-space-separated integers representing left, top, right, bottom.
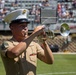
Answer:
4, 9, 29, 23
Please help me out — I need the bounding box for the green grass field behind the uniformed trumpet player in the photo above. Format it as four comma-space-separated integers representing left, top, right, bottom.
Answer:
0, 54, 76, 75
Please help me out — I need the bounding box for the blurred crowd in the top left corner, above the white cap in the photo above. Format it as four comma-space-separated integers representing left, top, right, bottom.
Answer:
0, 0, 17, 21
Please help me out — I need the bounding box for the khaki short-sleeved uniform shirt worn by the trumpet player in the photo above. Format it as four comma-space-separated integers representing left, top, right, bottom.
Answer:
0, 39, 43, 75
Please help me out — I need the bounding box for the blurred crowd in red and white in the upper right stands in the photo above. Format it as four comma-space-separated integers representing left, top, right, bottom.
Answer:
57, 0, 76, 18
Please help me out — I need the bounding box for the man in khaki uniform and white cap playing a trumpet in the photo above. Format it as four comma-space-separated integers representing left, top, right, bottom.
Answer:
0, 9, 54, 75
